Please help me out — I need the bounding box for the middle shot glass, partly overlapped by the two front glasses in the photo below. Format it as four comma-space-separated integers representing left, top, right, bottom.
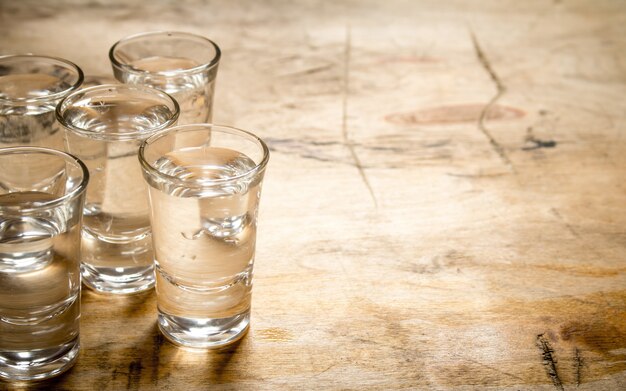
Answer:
56, 84, 179, 294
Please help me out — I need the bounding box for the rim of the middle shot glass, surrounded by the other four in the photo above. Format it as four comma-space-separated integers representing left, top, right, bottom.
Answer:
55, 84, 180, 140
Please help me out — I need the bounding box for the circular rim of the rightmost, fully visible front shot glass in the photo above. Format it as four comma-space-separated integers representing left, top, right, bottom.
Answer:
137, 123, 270, 188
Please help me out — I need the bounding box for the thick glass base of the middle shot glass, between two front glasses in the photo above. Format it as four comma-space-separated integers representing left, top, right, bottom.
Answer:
80, 263, 154, 295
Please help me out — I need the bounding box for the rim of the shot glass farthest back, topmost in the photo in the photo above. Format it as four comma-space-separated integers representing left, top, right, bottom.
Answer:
109, 30, 222, 77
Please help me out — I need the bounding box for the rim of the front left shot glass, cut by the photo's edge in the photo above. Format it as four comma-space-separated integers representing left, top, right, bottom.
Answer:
0, 146, 89, 211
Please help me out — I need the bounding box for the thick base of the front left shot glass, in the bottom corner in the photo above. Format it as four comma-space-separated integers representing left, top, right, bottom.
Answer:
0, 337, 80, 381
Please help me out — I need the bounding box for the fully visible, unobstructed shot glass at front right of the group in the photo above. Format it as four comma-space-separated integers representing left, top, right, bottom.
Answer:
139, 124, 269, 348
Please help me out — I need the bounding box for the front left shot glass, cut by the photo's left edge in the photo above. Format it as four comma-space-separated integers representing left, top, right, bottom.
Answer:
0, 147, 89, 381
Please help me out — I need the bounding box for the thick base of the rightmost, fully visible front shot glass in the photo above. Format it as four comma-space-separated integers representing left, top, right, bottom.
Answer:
158, 310, 250, 348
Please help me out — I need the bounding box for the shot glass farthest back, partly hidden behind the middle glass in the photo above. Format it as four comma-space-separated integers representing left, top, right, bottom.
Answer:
109, 31, 221, 125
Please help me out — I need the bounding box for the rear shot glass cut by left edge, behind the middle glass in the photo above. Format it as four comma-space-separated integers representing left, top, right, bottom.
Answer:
0, 55, 83, 150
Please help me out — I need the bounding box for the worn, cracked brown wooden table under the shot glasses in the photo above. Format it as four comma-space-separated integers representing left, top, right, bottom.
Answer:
0, 0, 626, 390
